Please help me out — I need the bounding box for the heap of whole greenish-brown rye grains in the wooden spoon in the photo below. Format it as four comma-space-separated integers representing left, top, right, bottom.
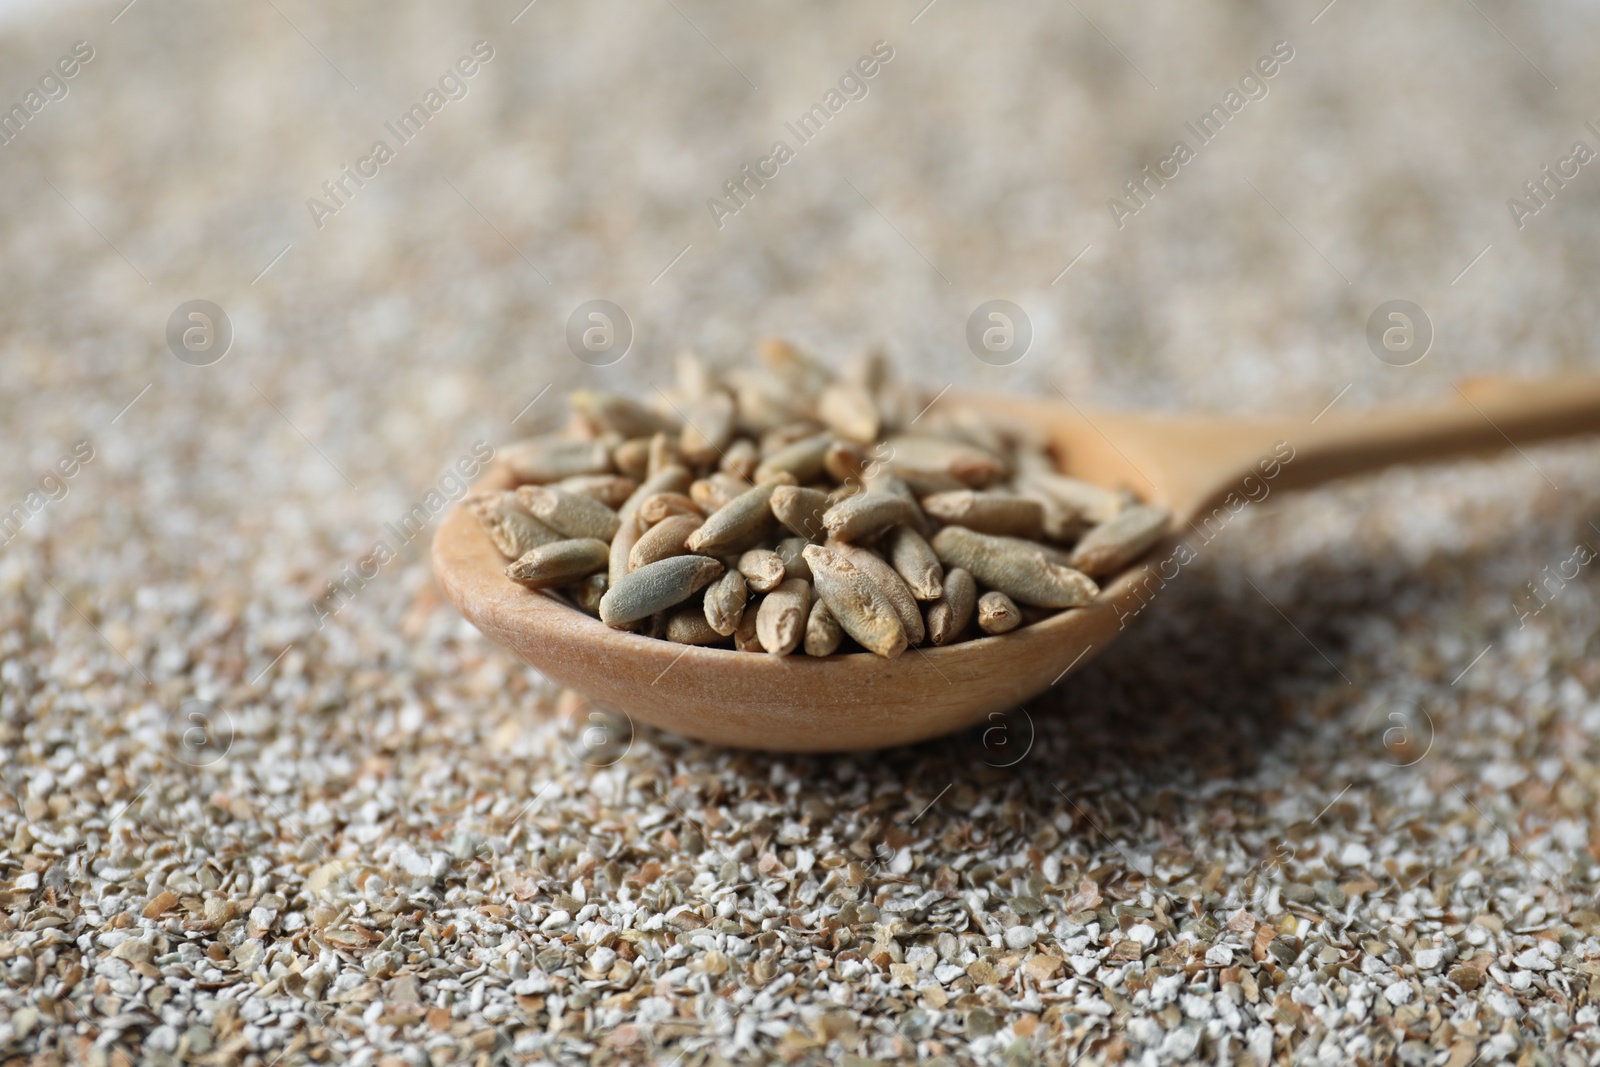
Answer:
467, 339, 1170, 657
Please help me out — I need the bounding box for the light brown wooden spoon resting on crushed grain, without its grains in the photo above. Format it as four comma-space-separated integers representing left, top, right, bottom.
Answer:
434, 378, 1600, 752
